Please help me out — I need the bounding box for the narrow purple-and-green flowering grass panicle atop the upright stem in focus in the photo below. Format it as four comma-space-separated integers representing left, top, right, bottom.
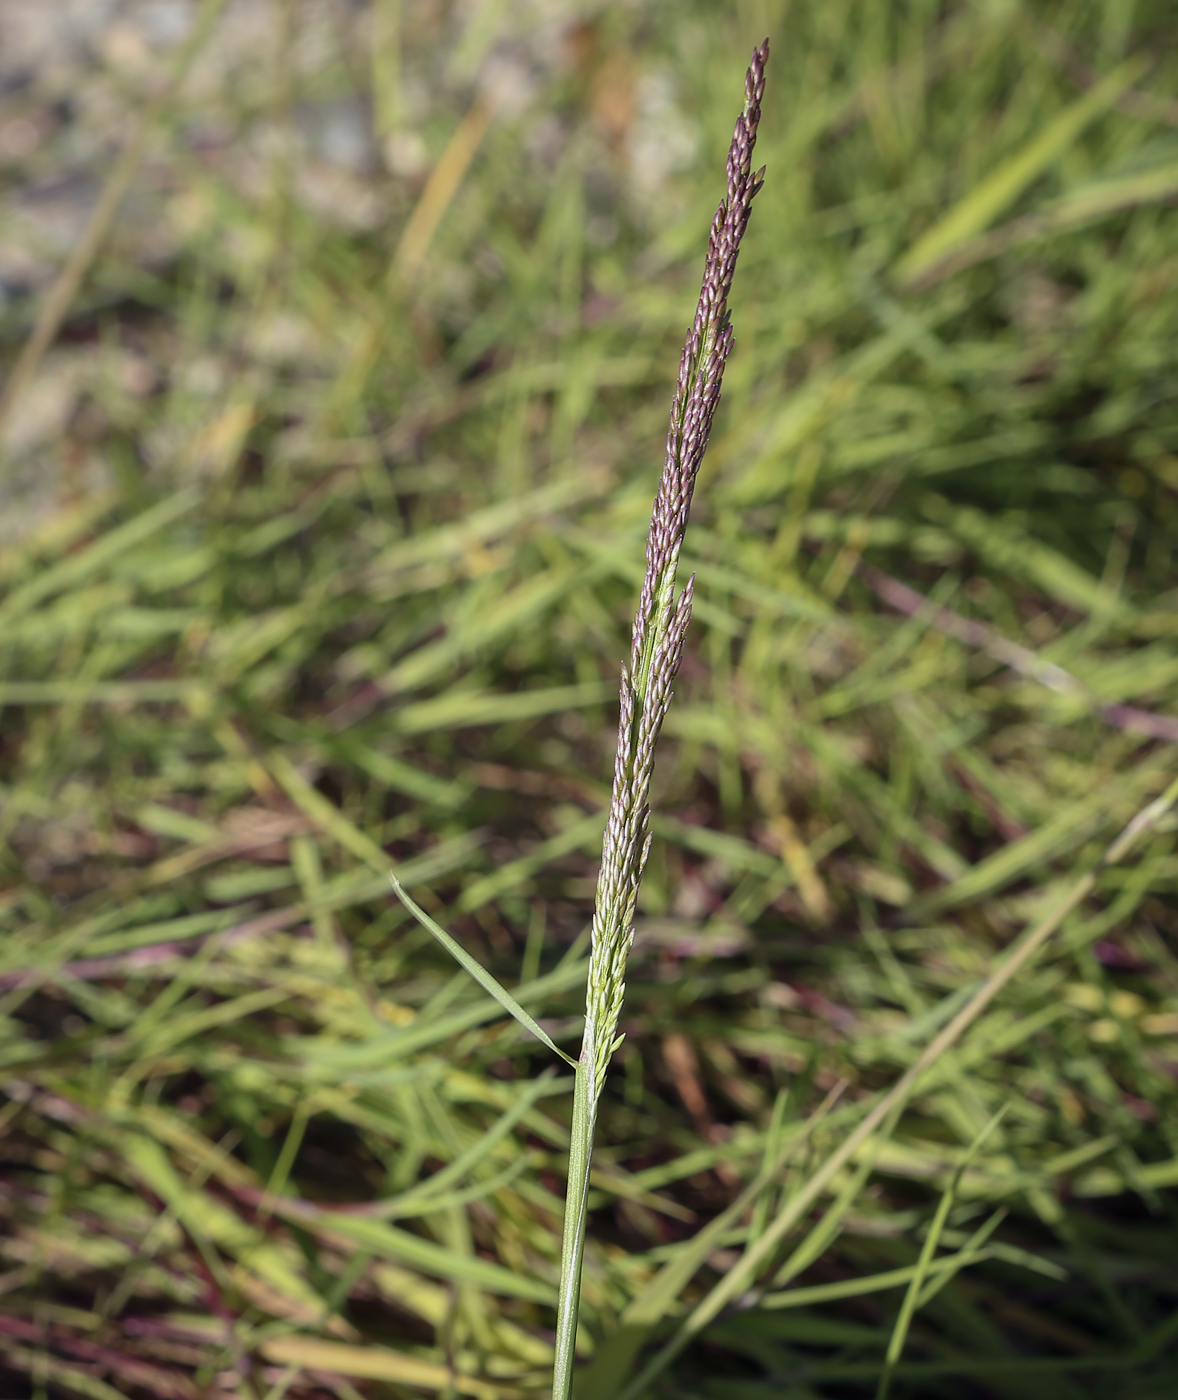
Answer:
581, 39, 769, 1103
